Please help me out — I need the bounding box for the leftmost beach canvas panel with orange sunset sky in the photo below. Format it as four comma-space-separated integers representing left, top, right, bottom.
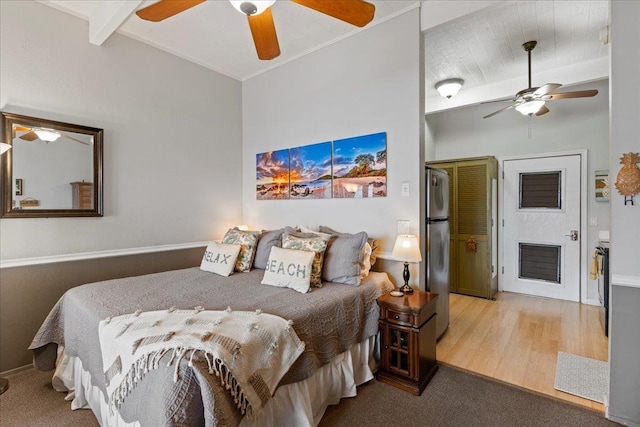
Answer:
256, 149, 289, 200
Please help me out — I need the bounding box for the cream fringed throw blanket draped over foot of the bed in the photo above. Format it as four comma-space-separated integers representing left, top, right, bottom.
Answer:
99, 307, 305, 415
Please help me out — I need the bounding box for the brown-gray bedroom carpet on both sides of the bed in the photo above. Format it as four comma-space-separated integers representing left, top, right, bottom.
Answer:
0, 366, 618, 427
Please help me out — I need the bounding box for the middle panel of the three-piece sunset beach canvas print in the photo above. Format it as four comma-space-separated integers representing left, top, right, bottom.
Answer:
289, 142, 331, 199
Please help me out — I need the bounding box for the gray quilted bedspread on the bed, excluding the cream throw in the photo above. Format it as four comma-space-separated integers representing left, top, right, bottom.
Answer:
29, 268, 392, 426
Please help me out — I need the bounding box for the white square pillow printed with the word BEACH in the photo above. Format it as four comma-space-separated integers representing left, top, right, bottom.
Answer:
261, 246, 315, 294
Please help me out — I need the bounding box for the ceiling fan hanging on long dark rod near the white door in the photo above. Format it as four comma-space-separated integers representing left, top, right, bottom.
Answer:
483, 40, 598, 119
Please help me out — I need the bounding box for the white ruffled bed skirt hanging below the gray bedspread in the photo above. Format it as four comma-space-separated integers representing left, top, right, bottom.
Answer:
52, 336, 379, 427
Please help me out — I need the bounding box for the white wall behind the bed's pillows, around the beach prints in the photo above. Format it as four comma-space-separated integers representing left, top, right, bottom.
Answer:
243, 9, 424, 284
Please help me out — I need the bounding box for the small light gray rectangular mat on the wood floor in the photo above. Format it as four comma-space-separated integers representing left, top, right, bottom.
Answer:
553, 351, 609, 404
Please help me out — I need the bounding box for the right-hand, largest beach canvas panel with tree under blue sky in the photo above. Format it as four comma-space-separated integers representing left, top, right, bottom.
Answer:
333, 132, 387, 198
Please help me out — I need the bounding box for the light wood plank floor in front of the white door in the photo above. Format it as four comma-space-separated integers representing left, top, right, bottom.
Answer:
436, 292, 608, 412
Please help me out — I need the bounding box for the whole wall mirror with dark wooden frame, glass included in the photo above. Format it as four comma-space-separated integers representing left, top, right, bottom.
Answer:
0, 112, 103, 218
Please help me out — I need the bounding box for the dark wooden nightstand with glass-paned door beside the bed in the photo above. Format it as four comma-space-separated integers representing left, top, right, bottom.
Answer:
377, 290, 438, 396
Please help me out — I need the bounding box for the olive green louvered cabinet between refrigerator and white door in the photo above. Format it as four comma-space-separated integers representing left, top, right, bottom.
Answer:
427, 157, 498, 299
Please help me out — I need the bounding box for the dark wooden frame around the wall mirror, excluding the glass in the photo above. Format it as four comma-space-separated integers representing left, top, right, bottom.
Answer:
0, 112, 104, 218
